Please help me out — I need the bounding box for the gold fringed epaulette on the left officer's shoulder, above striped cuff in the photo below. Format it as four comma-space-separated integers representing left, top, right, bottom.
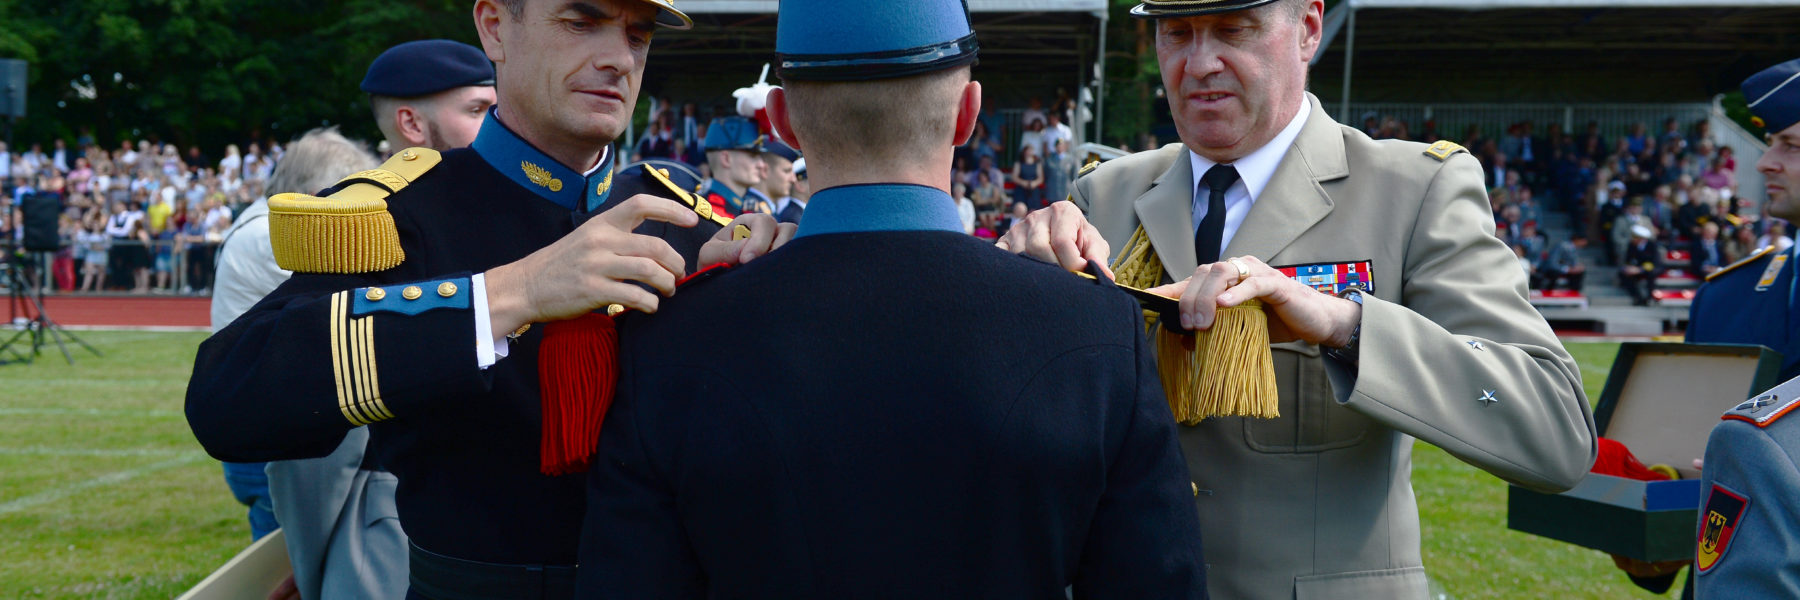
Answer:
268, 148, 443, 274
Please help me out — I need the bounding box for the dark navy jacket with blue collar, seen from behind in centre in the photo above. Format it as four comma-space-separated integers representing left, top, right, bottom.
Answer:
580, 186, 1206, 598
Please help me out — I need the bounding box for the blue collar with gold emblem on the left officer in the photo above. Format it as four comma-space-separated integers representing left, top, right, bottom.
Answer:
468, 110, 612, 213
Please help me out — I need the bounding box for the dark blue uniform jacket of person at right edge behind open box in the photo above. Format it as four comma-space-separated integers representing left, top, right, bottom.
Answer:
1687, 249, 1800, 380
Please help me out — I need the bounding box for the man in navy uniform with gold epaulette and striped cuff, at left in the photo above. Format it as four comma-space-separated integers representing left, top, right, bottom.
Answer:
187, 0, 788, 598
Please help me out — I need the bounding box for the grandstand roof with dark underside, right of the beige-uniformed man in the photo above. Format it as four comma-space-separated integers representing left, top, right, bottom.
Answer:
1312, 0, 1800, 103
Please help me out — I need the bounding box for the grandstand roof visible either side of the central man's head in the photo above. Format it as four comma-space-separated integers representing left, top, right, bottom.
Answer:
644, 0, 1109, 118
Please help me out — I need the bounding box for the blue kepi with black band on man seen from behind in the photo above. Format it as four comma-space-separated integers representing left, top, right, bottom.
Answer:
776, 0, 977, 81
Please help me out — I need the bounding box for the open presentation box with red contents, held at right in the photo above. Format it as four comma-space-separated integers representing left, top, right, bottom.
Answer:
1507, 342, 1782, 562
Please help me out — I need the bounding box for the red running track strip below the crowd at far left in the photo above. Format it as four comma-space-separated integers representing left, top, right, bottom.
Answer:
0, 295, 212, 330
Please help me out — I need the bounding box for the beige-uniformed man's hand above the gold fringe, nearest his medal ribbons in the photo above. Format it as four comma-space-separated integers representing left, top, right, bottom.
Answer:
1150, 256, 1363, 348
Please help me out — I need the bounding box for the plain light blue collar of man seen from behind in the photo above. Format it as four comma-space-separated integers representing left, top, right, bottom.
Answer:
794, 184, 963, 238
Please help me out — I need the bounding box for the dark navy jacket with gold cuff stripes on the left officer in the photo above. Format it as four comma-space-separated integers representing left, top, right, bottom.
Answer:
187, 114, 718, 566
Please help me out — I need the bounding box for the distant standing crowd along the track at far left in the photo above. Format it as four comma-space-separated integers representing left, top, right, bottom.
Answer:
0, 135, 281, 294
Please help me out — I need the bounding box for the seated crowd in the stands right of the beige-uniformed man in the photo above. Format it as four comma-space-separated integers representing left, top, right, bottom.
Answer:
1363, 114, 1793, 305
